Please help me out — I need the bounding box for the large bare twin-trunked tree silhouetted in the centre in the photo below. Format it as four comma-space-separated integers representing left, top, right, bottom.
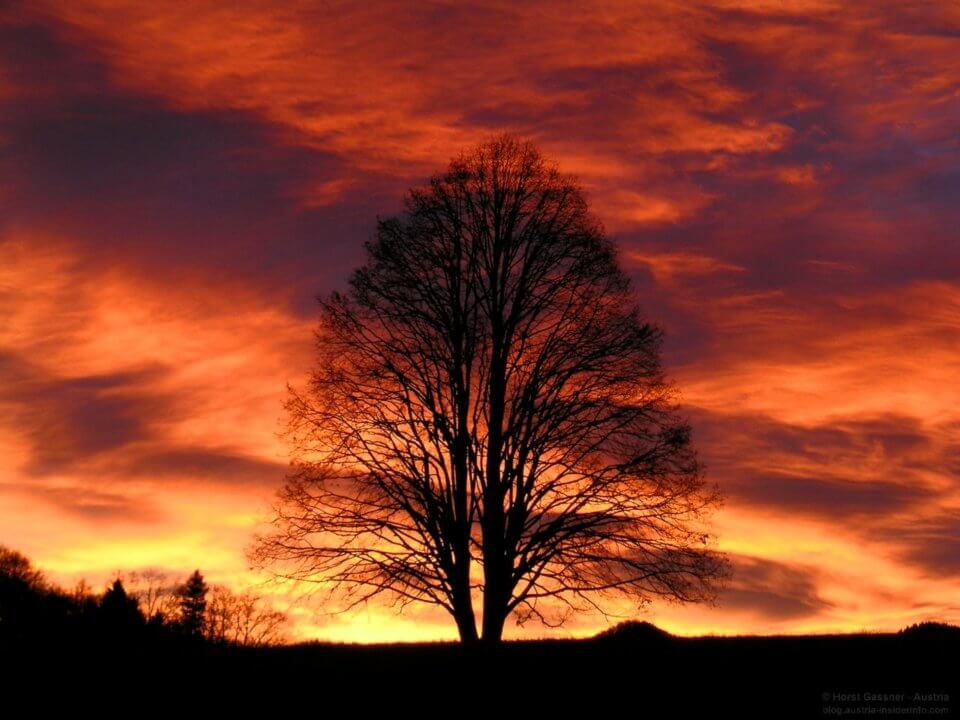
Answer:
253, 136, 725, 642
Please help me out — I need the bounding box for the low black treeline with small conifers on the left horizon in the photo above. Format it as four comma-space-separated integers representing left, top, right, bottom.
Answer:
0, 546, 287, 647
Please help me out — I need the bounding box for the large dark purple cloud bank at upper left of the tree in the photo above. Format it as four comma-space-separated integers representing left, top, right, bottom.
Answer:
0, 13, 397, 305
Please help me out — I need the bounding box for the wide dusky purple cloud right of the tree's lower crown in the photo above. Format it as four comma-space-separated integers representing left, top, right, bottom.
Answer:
691, 410, 956, 530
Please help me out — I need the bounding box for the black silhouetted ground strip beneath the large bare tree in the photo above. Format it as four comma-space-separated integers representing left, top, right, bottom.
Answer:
9, 623, 960, 718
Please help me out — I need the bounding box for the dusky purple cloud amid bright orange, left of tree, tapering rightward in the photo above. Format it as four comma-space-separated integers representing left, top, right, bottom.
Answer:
0, 353, 286, 490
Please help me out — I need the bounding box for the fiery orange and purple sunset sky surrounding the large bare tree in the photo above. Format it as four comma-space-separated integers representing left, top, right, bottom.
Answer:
0, 0, 960, 641
